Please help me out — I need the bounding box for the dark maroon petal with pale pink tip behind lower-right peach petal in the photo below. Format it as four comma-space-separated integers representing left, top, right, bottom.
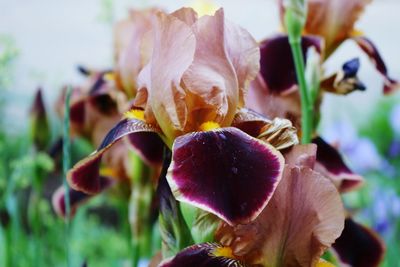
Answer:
313, 137, 364, 192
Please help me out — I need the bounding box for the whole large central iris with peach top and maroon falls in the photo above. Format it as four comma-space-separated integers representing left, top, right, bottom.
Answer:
67, 8, 297, 228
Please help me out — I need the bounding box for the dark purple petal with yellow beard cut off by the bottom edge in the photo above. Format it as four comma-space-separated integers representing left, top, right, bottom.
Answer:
160, 243, 246, 267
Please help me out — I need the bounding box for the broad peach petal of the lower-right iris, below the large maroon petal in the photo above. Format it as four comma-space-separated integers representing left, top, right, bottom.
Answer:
216, 162, 344, 267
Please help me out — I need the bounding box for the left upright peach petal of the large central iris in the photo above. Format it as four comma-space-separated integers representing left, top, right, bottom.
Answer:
146, 12, 196, 139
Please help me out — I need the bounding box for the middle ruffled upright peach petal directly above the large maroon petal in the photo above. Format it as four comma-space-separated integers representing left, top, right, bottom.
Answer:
182, 9, 239, 130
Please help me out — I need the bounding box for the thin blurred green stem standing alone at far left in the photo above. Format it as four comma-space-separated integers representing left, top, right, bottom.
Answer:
63, 88, 71, 266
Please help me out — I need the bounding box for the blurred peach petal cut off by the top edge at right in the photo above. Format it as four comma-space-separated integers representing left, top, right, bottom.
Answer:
305, 0, 371, 56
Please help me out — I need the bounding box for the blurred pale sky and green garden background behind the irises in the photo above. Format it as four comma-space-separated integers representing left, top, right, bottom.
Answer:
0, 0, 400, 267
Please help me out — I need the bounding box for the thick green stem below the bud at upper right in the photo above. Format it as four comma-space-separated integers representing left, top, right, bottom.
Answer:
289, 37, 314, 144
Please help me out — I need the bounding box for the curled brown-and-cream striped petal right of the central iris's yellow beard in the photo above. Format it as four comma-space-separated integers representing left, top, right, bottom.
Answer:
232, 108, 298, 150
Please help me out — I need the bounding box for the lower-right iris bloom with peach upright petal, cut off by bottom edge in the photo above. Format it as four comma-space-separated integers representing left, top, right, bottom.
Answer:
160, 145, 344, 267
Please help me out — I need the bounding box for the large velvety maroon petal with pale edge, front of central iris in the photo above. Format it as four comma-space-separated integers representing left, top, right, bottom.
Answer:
167, 127, 284, 225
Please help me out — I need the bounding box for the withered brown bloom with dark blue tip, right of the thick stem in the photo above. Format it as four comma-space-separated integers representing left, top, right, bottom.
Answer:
321, 58, 366, 95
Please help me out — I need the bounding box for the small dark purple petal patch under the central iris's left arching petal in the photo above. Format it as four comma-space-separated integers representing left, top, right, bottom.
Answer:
128, 133, 165, 166
